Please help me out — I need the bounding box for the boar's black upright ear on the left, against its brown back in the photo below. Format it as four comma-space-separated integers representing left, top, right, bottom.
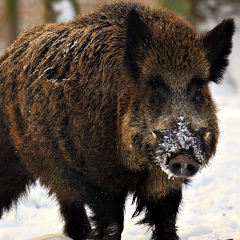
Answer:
124, 8, 151, 77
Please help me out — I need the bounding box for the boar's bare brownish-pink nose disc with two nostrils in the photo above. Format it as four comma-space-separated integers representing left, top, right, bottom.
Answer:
168, 154, 199, 178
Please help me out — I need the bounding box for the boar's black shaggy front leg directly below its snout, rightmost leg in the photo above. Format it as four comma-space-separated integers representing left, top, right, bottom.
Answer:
136, 190, 182, 240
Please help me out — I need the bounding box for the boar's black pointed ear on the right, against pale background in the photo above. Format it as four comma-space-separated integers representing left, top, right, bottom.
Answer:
202, 18, 235, 83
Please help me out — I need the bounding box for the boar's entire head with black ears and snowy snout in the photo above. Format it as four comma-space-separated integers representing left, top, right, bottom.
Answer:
122, 9, 234, 178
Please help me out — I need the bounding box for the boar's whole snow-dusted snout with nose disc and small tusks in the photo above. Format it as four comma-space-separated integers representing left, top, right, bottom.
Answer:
152, 117, 208, 178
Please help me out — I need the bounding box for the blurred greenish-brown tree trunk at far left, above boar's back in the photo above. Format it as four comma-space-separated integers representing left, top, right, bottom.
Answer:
5, 0, 18, 45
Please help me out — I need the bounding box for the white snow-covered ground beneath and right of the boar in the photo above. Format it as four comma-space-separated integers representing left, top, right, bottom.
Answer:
0, 5, 240, 240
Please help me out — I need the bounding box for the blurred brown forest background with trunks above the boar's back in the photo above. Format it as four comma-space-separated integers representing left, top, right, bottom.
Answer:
0, 0, 240, 53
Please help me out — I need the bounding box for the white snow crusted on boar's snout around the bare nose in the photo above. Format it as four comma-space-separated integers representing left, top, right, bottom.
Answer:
155, 116, 204, 178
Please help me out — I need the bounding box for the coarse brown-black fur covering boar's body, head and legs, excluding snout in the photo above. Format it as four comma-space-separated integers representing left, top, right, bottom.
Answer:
0, 3, 234, 239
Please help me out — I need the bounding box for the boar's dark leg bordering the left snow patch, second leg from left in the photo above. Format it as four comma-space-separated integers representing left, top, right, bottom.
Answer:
60, 202, 91, 240
